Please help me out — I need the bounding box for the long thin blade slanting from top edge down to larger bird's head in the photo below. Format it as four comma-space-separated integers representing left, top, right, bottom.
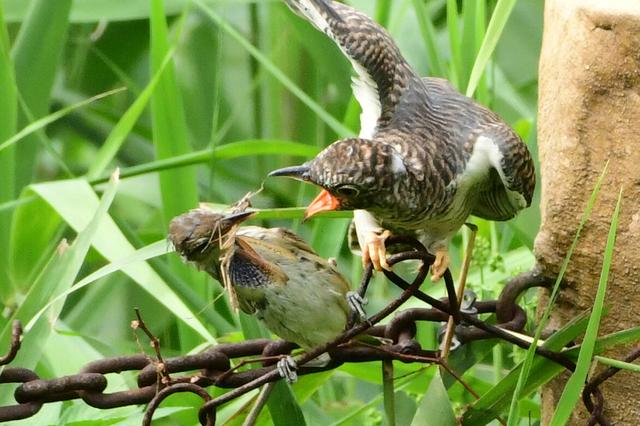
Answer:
194, 0, 353, 137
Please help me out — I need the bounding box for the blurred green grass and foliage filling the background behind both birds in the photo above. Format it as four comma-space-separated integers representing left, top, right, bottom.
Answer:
0, 0, 600, 425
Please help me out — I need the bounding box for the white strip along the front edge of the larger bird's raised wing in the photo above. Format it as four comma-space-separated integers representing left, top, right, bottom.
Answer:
288, 0, 382, 139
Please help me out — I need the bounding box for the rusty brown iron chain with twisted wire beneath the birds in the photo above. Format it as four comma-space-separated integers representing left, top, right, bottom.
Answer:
0, 238, 640, 425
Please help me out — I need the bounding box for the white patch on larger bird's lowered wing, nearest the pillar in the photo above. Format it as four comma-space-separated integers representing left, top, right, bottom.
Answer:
464, 136, 527, 209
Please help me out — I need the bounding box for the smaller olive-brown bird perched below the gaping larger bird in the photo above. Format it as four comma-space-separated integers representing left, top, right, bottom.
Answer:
168, 208, 364, 381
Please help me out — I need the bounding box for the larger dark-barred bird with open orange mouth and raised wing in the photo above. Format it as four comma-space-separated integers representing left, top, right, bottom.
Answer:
270, 0, 535, 279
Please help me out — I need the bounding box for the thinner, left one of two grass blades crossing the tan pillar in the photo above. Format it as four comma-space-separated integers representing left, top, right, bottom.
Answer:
508, 163, 608, 426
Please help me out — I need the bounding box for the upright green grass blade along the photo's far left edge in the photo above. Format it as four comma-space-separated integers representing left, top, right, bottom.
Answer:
0, 2, 18, 304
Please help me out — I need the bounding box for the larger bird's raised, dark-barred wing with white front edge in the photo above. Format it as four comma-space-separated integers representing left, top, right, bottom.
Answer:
285, 0, 415, 139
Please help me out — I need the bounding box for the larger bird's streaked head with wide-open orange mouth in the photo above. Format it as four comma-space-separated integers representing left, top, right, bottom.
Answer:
269, 139, 407, 219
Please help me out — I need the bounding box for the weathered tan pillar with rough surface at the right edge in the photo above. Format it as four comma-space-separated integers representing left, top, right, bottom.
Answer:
535, 0, 640, 425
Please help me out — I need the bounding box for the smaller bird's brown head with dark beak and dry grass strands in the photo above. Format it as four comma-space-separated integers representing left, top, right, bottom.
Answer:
168, 208, 255, 266
